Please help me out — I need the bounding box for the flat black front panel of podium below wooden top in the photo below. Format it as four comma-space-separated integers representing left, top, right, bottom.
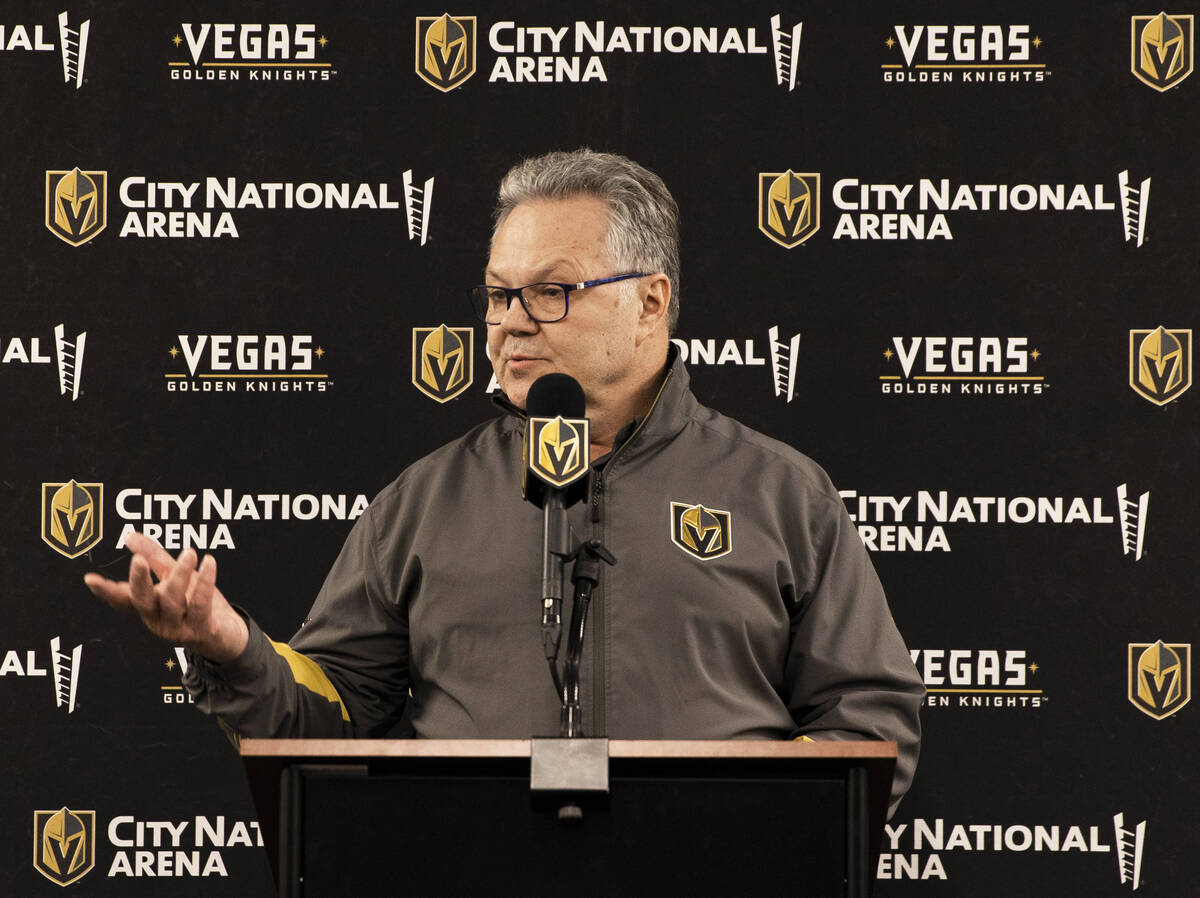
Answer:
292, 767, 846, 898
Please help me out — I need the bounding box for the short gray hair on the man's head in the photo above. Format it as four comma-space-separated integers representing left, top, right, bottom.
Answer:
492, 146, 679, 334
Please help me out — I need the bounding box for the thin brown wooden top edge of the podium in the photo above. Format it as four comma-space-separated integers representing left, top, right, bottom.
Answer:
241, 738, 896, 760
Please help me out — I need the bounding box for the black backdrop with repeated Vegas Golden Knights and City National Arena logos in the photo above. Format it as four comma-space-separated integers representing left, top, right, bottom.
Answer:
0, 0, 1200, 898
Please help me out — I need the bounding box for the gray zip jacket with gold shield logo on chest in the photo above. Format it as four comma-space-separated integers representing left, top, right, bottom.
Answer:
185, 360, 924, 807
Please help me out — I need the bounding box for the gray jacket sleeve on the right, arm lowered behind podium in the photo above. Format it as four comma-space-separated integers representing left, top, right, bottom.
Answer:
785, 493, 925, 816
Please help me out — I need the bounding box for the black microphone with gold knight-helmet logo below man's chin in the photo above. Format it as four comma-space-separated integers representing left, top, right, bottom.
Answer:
521, 372, 590, 694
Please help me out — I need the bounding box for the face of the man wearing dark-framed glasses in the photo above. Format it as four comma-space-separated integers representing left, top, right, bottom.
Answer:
486, 196, 641, 408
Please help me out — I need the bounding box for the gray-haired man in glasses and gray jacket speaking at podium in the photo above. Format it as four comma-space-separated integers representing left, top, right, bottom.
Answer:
86, 150, 924, 808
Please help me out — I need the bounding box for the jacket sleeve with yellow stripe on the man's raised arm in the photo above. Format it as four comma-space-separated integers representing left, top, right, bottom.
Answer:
184, 501, 408, 738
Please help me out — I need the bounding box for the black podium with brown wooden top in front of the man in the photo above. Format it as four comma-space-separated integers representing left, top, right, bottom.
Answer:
241, 738, 896, 898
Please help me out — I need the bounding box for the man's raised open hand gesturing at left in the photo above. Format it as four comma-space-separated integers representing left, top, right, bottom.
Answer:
83, 533, 250, 661
